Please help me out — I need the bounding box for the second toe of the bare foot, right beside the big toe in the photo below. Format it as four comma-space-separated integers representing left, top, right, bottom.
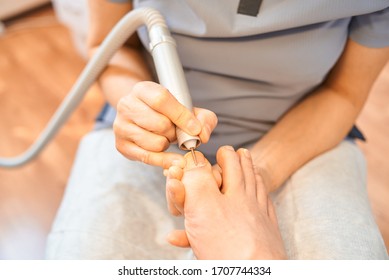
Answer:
216, 146, 244, 194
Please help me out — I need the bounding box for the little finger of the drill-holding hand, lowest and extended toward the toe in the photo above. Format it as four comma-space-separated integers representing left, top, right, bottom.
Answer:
116, 140, 185, 169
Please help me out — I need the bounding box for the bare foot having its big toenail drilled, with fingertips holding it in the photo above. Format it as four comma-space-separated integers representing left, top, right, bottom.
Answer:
166, 147, 286, 259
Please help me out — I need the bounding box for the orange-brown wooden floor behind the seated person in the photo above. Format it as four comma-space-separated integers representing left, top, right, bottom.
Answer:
0, 4, 389, 259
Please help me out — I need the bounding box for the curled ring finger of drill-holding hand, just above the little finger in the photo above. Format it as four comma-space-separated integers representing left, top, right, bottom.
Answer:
114, 122, 170, 152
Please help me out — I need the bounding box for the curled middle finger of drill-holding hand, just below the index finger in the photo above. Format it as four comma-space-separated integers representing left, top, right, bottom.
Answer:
115, 94, 176, 142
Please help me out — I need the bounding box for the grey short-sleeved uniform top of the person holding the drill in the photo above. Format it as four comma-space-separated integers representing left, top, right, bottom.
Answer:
103, 0, 389, 158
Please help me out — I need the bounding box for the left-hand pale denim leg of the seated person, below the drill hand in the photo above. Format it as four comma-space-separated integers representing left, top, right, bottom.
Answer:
46, 129, 188, 259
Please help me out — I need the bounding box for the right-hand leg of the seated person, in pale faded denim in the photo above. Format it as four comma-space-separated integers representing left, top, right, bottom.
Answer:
272, 141, 388, 259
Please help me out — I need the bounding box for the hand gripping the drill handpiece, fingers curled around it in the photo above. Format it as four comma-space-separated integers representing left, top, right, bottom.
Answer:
114, 82, 217, 168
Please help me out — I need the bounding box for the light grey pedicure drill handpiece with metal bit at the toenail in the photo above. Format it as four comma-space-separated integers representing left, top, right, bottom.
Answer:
149, 21, 201, 165
